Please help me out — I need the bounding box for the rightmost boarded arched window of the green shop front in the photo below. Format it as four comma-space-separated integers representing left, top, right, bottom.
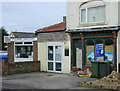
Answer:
105, 39, 114, 64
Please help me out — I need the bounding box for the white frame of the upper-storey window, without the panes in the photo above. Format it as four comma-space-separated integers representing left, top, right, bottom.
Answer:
80, 5, 106, 24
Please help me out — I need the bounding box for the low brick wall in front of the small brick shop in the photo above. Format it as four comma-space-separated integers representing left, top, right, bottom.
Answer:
2, 60, 40, 75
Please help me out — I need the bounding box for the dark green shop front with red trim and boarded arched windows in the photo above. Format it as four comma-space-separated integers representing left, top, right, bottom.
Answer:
69, 28, 117, 71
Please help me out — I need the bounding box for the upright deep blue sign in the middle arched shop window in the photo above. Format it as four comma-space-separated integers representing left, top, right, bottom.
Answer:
96, 43, 104, 57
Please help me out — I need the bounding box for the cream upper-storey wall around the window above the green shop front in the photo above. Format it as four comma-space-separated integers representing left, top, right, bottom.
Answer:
67, 0, 120, 30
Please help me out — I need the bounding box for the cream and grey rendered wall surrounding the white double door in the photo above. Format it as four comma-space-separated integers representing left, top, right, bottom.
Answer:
38, 32, 70, 73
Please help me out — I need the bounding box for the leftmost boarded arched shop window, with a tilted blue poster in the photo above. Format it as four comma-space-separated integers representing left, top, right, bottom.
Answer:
86, 39, 94, 65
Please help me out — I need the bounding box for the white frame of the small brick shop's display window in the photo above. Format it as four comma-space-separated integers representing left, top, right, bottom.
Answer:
14, 41, 34, 62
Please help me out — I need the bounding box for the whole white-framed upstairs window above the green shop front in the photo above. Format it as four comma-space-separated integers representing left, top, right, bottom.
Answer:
80, 5, 106, 23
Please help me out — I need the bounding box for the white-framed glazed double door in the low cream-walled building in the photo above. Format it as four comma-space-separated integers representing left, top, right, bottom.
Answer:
47, 43, 62, 72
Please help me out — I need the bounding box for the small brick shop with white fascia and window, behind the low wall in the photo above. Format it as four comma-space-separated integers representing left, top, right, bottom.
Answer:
8, 32, 38, 63
